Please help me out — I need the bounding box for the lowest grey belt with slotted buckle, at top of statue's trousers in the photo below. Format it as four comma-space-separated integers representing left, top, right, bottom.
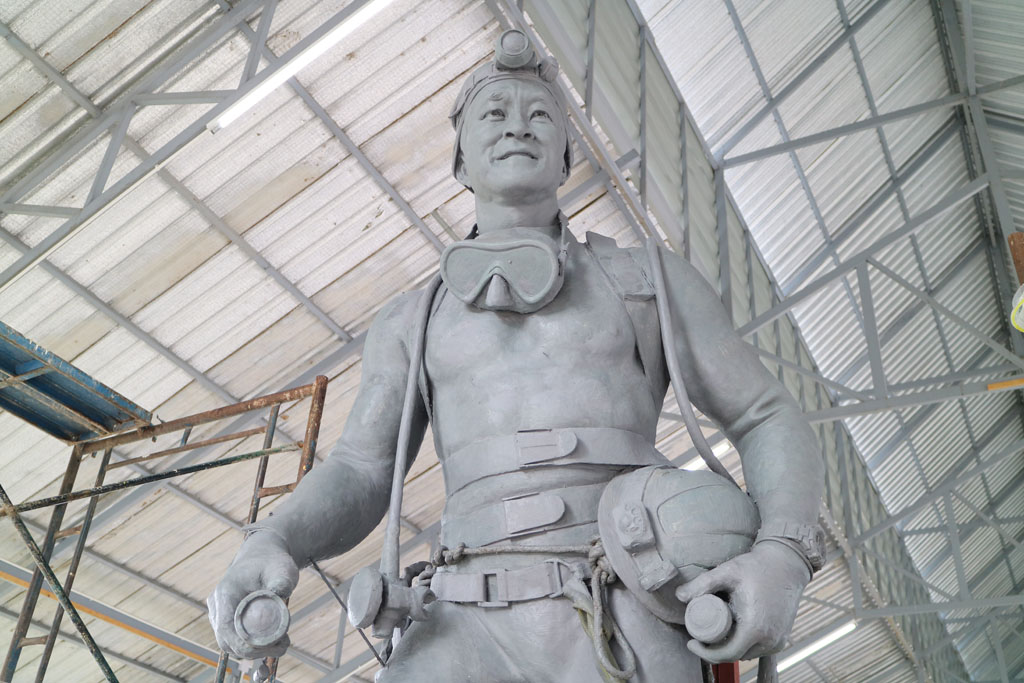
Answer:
430, 560, 589, 607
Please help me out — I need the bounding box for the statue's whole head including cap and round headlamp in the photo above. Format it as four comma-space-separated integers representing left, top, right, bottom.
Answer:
450, 30, 572, 201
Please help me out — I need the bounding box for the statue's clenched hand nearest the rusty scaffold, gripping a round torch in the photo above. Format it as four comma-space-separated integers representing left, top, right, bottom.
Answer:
206, 530, 299, 659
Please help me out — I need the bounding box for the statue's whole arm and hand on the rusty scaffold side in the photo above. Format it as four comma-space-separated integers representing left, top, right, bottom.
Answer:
207, 292, 427, 658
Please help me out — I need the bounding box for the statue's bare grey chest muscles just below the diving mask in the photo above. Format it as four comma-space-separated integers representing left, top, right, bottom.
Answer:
426, 252, 636, 382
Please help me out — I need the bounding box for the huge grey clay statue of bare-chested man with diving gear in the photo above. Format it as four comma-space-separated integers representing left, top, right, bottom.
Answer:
209, 31, 823, 683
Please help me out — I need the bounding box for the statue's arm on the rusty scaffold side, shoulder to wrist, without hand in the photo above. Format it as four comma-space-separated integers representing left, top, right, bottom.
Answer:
257, 292, 427, 567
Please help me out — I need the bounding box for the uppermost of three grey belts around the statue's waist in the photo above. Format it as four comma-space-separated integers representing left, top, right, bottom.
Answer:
442, 427, 669, 496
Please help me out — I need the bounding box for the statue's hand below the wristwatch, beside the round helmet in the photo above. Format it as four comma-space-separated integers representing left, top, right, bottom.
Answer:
676, 542, 810, 663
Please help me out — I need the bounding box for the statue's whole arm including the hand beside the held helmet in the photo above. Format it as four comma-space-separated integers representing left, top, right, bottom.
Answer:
662, 245, 824, 661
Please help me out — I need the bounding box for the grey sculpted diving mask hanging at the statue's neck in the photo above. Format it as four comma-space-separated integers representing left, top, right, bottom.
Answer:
440, 216, 568, 313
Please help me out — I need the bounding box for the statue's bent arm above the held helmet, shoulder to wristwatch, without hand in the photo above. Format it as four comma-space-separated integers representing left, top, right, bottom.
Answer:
662, 251, 824, 524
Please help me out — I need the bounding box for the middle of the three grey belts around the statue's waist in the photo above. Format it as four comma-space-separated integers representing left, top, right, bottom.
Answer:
443, 481, 606, 547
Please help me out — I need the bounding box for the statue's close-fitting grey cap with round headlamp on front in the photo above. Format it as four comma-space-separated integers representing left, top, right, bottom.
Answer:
449, 29, 572, 190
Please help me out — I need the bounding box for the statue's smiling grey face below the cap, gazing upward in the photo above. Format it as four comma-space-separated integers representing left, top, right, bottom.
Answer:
456, 79, 568, 203
